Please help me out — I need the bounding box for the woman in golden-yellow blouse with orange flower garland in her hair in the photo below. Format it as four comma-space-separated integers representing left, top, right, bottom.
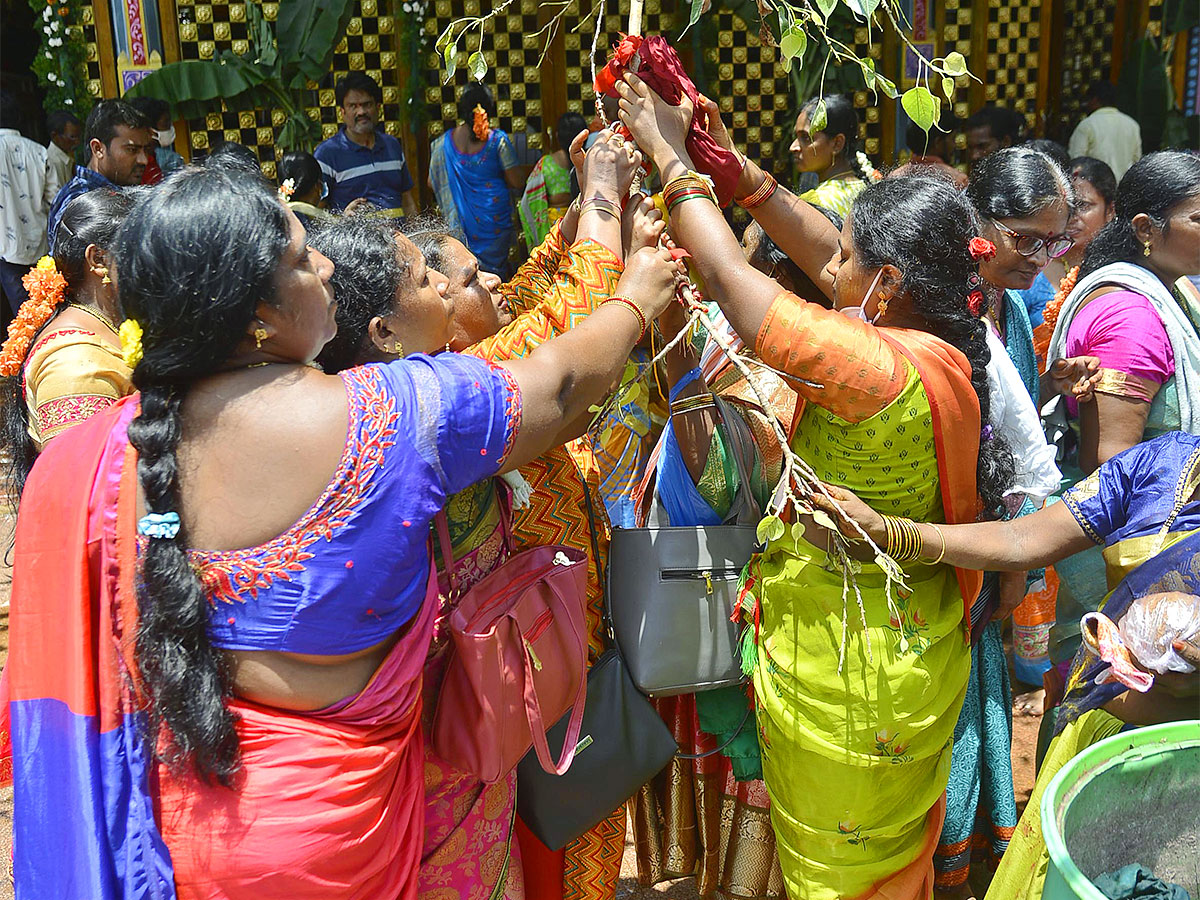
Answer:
0, 190, 133, 502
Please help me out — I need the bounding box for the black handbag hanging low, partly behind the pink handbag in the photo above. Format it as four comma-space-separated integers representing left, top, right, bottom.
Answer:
517, 481, 678, 850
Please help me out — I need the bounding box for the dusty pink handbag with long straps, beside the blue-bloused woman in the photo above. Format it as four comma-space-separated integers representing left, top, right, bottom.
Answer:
433, 496, 588, 784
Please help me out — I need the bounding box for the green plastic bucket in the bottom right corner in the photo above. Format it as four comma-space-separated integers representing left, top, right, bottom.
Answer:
1042, 721, 1200, 900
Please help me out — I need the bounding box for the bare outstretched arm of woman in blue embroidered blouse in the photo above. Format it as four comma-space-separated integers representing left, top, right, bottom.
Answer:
500, 248, 679, 470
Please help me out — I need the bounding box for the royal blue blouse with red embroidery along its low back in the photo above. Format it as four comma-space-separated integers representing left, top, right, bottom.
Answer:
191, 353, 521, 655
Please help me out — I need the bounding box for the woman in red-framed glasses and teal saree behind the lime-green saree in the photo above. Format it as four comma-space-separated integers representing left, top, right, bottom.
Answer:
934, 146, 1074, 898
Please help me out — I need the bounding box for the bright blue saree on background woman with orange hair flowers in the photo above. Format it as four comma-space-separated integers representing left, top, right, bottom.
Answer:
430, 128, 517, 277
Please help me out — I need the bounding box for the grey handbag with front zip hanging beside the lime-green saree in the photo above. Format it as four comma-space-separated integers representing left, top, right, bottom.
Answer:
608, 396, 760, 697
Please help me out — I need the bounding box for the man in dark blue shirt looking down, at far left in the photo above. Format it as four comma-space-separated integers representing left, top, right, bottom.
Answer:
46, 100, 155, 253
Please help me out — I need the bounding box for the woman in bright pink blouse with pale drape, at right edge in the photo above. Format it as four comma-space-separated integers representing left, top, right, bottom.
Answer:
1046, 150, 1200, 676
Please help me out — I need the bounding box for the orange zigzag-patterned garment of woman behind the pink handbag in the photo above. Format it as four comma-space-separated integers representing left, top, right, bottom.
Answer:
467, 223, 625, 900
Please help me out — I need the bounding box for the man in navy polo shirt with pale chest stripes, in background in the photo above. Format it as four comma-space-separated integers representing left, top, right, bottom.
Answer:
312, 72, 416, 218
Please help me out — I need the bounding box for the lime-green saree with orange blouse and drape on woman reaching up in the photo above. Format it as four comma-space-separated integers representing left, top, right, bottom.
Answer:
748, 294, 979, 900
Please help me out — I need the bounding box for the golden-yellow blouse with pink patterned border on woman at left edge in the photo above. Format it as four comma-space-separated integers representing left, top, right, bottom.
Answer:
24, 324, 133, 451
